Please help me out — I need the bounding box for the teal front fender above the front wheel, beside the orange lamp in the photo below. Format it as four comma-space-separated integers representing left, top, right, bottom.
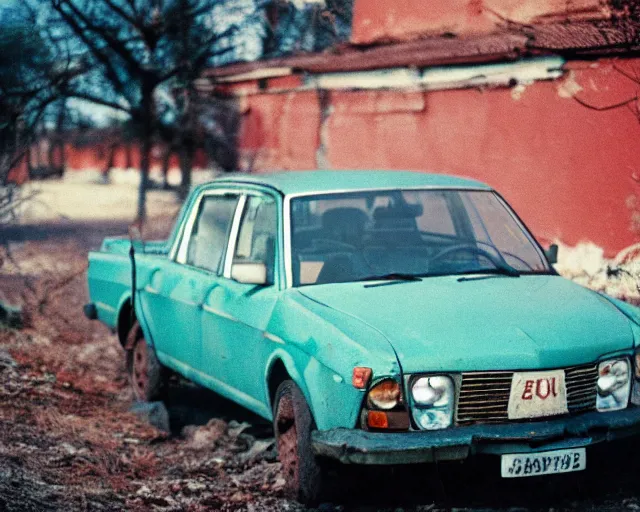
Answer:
265, 292, 401, 430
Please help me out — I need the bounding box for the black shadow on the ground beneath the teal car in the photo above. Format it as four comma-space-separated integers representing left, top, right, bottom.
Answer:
162, 383, 640, 512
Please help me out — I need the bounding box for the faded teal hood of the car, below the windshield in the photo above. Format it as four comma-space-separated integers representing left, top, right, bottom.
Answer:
299, 275, 634, 373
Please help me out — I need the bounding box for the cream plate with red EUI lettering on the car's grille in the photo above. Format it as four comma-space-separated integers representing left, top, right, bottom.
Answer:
507, 370, 569, 420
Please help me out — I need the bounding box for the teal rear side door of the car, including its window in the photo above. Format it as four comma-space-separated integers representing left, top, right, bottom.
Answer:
144, 189, 240, 378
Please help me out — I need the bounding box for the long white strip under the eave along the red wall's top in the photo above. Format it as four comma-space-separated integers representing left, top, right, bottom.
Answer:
305, 57, 564, 90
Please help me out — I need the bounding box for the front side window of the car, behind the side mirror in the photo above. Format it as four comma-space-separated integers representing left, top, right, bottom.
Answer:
233, 196, 278, 282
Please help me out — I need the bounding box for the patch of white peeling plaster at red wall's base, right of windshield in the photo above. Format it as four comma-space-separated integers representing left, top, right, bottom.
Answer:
555, 242, 640, 301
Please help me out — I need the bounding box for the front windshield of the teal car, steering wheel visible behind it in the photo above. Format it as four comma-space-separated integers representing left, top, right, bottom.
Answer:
291, 189, 550, 286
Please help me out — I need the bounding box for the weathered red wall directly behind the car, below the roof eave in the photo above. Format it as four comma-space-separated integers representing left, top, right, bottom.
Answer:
241, 60, 640, 255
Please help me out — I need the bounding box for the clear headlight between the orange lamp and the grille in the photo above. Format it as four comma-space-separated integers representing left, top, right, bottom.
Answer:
411, 375, 455, 430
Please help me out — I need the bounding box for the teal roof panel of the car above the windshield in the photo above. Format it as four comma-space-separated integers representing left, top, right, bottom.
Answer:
210, 170, 491, 195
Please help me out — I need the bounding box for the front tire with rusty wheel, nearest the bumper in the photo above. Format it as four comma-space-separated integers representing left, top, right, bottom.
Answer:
273, 380, 327, 505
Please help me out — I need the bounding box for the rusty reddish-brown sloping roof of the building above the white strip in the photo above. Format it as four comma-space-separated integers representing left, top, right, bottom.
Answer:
197, 19, 640, 91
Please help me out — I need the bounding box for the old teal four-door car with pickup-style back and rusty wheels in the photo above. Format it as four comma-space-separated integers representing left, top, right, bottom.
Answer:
85, 171, 640, 502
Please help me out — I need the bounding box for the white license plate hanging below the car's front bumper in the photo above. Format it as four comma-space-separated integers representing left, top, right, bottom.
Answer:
501, 448, 587, 478
